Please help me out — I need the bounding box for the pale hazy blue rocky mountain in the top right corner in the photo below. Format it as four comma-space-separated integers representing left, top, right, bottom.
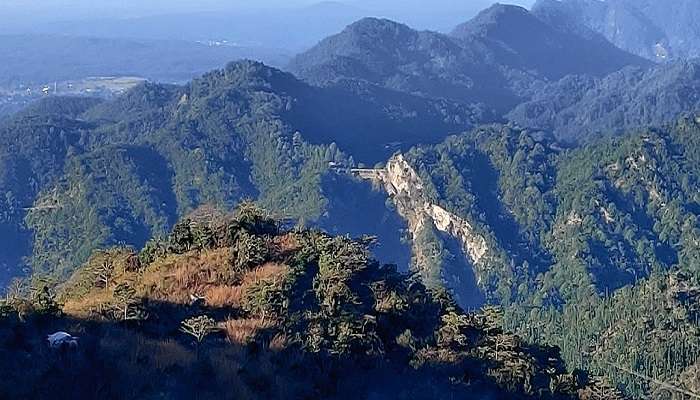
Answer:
532, 0, 700, 62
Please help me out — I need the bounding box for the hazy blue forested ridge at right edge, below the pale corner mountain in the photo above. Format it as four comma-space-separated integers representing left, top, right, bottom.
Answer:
508, 61, 700, 143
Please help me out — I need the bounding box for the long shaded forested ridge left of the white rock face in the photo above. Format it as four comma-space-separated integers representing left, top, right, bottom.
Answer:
0, 62, 480, 284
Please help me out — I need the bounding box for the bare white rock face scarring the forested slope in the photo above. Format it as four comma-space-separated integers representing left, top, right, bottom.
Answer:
357, 154, 489, 267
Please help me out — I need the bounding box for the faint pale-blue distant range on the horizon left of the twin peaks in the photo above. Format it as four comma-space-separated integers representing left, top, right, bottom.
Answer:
10, 1, 368, 54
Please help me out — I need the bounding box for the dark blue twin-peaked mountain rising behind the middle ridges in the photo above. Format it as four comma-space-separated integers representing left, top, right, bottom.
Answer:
290, 5, 648, 113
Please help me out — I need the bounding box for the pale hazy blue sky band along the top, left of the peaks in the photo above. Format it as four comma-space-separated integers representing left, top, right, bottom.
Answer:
0, 0, 534, 53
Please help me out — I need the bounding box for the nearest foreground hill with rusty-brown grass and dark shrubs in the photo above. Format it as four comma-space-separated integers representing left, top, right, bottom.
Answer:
0, 203, 622, 400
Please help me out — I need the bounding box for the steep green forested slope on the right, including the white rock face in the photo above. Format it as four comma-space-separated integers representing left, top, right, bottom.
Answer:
357, 118, 700, 396
